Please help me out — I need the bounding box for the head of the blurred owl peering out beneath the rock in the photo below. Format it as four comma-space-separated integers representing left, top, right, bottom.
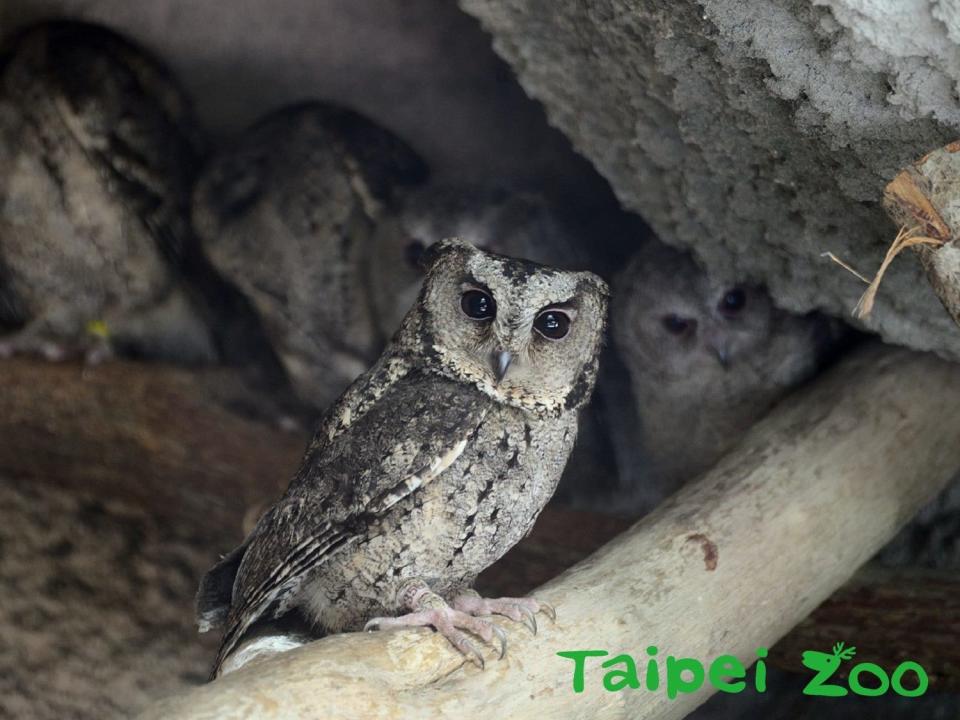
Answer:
614, 242, 786, 387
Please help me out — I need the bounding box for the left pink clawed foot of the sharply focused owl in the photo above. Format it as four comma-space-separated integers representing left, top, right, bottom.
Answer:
363, 585, 507, 670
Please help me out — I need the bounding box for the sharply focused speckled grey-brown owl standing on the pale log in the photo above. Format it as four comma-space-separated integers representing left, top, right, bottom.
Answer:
198, 241, 607, 674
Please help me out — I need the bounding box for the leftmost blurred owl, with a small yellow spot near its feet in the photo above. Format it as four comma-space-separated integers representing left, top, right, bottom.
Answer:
0, 22, 214, 360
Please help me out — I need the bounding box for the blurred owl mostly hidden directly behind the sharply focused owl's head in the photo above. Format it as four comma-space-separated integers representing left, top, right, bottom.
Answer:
369, 184, 589, 337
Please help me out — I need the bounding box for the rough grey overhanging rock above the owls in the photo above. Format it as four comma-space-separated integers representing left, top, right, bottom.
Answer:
461, 0, 960, 358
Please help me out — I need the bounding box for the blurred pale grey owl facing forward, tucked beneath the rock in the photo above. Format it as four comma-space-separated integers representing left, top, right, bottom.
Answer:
601, 241, 839, 512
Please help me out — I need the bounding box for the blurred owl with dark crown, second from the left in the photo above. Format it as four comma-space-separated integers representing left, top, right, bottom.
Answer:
192, 102, 427, 408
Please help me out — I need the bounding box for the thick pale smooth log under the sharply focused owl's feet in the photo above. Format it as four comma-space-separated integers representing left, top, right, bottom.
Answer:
142, 346, 960, 720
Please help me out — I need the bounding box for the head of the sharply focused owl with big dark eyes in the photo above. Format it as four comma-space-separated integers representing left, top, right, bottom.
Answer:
399, 240, 608, 414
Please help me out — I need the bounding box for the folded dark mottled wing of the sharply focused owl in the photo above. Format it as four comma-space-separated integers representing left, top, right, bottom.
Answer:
214, 372, 491, 673
